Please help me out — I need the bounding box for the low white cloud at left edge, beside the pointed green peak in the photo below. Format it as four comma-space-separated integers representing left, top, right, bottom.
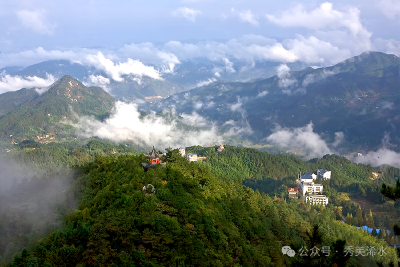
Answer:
0, 74, 55, 94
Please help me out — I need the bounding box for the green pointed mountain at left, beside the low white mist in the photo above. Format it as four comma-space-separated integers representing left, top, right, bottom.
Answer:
0, 75, 115, 139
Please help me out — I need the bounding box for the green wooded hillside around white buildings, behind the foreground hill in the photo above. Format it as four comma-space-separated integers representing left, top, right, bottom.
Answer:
186, 146, 400, 241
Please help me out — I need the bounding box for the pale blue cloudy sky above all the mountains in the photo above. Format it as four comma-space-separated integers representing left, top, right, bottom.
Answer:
0, 0, 400, 67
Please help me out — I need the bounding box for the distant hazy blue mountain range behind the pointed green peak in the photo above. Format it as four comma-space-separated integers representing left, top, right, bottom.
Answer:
0, 58, 304, 101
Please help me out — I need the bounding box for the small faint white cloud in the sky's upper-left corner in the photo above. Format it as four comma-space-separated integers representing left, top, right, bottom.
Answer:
17, 10, 56, 35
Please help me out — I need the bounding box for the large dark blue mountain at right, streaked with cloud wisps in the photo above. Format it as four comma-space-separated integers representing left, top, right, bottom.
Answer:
151, 52, 400, 151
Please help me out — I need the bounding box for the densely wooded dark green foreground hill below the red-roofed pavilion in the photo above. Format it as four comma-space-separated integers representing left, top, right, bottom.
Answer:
4, 150, 397, 266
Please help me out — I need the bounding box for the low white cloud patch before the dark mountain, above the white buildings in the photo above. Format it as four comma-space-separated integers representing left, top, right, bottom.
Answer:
266, 122, 332, 158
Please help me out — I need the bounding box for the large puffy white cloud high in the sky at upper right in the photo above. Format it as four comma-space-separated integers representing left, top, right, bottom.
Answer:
267, 2, 372, 58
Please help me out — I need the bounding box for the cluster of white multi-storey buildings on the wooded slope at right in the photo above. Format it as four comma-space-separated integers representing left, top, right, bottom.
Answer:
288, 169, 332, 206
